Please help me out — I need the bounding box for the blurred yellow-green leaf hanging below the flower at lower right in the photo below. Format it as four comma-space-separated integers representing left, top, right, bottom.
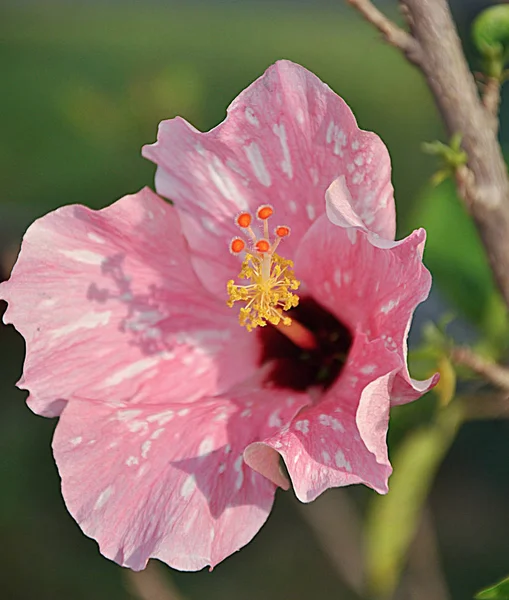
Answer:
366, 403, 462, 598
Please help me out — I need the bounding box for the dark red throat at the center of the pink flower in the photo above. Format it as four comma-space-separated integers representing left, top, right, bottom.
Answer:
257, 297, 352, 391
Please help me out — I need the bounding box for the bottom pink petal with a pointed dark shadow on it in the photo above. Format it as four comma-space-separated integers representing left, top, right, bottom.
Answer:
53, 383, 308, 570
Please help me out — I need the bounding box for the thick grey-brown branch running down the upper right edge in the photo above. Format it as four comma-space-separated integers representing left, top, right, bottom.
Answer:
347, 0, 509, 307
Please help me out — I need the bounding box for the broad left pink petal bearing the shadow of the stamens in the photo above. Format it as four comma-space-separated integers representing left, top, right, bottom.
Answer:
0, 189, 259, 416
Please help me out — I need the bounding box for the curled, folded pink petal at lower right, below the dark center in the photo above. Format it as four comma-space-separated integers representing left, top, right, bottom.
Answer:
246, 334, 401, 502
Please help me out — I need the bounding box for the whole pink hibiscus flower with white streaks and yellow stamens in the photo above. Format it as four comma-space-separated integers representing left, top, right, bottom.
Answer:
0, 61, 435, 570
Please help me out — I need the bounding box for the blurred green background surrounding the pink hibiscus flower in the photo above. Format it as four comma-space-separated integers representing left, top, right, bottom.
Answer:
0, 0, 509, 600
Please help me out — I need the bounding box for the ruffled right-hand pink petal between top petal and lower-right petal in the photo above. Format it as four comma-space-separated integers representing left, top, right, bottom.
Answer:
295, 216, 438, 404
